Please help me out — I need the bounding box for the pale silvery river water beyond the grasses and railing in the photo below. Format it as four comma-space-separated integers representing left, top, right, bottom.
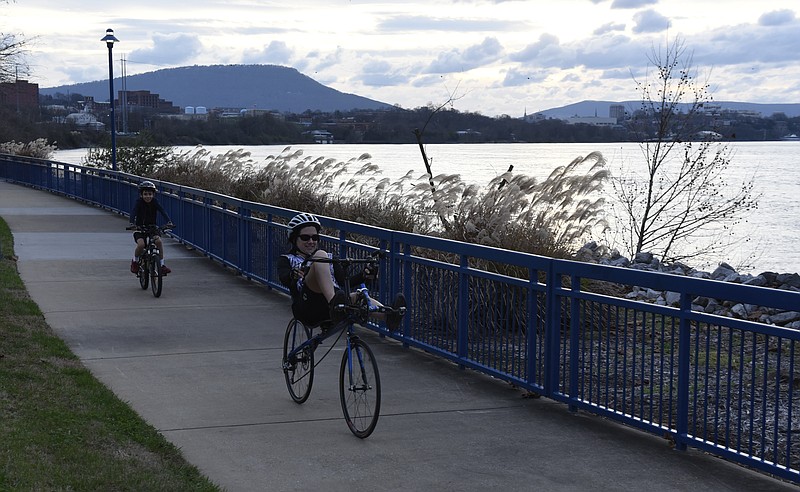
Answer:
54, 142, 800, 274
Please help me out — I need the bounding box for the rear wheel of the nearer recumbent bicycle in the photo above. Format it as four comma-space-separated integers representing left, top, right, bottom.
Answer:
283, 319, 314, 403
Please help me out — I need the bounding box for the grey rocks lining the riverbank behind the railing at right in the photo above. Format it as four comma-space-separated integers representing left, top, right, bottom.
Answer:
575, 241, 800, 330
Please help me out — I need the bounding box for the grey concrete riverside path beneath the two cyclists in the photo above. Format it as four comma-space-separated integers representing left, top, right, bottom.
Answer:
0, 181, 797, 492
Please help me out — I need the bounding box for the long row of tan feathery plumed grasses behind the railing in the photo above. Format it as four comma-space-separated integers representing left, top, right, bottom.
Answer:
148, 147, 608, 264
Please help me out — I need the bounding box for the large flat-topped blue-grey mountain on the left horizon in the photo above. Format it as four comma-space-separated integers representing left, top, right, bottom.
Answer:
39, 65, 392, 113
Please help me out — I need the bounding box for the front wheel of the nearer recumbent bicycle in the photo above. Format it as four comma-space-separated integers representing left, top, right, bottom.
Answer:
339, 338, 381, 439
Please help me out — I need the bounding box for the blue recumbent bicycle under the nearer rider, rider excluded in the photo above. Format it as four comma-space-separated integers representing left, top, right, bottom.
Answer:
282, 254, 406, 439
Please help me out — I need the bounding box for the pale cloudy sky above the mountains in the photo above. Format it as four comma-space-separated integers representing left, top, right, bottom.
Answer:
0, 0, 800, 117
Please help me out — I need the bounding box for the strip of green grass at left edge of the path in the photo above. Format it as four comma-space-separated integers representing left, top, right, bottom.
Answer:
0, 219, 220, 491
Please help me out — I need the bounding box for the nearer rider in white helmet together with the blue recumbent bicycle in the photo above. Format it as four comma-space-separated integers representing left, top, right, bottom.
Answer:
278, 214, 406, 438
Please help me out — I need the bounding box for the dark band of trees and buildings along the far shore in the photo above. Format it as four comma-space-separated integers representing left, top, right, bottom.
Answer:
0, 89, 800, 149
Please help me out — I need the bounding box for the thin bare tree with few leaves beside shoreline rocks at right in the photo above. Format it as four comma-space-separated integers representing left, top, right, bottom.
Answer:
612, 39, 759, 261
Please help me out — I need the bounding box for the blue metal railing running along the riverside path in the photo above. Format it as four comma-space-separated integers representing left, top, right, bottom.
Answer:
0, 155, 800, 483
